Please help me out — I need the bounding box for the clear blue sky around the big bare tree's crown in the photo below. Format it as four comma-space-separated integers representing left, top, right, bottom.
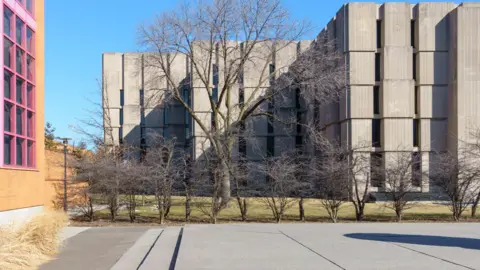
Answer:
45, 0, 458, 146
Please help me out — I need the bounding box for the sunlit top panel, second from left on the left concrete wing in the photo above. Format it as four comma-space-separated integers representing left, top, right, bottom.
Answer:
123, 53, 142, 105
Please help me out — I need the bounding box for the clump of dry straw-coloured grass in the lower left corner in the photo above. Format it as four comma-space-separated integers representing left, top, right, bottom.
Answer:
0, 212, 68, 270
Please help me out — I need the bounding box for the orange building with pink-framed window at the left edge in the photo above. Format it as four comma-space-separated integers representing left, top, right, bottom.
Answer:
0, 0, 46, 224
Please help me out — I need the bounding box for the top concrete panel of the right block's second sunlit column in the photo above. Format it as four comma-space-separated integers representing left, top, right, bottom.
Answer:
382, 3, 412, 47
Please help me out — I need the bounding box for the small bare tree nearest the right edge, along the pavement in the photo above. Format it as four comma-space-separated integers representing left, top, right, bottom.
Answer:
429, 149, 480, 221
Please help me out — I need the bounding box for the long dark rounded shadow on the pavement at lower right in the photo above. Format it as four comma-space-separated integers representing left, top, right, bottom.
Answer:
344, 233, 480, 250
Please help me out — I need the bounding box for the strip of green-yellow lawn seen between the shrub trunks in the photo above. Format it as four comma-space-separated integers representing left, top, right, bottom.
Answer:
80, 196, 478, 223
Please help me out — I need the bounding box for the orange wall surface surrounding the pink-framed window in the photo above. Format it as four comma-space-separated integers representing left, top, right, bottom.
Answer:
0, 0, 45, 211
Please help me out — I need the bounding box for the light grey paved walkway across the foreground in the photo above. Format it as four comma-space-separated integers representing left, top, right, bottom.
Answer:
41, 223, 480, 270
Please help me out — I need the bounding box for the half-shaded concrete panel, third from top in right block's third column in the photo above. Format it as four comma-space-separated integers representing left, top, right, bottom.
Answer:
418, 86, 448, 118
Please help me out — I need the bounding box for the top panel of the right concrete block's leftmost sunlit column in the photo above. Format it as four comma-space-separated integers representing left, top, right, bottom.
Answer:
347, 3, 377, 52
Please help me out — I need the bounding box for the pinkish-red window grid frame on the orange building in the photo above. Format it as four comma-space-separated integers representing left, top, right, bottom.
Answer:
2, 1, 36, 168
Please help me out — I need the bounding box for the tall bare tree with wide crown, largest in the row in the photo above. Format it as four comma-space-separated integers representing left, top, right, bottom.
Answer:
139, 0, 345, 212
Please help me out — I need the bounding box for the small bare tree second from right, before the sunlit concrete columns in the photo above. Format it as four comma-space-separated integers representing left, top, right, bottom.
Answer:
376, 148, 422, 221
